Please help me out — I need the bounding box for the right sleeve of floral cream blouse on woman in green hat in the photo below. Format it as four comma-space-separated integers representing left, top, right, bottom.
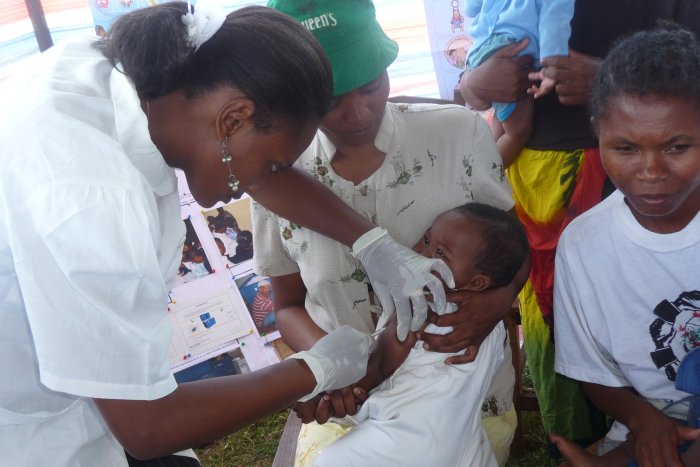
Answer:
464, 109, 515, 211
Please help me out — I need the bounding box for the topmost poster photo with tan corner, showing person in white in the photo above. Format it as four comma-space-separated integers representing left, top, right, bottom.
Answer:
202, 198, 253, 268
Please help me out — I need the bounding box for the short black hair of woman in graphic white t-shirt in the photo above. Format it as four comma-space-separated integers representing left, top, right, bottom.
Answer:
589, 21, 700, 120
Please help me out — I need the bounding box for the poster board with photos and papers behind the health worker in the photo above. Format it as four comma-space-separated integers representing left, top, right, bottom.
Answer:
168, 171, 280, 381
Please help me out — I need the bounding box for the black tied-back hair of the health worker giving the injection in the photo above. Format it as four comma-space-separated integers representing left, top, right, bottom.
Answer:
96, 2, 333, 130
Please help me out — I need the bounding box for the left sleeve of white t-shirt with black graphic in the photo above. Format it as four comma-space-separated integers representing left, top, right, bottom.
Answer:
554, 231, 631, 387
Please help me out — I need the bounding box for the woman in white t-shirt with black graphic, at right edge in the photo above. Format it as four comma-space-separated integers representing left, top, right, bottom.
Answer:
551, 27, 700, 466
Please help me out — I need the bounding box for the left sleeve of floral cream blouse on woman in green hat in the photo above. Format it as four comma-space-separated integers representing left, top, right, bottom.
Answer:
252, 201, 299, 277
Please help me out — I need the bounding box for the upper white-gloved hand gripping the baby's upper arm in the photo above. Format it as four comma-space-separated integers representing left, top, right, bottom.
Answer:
352, 227, 455, 341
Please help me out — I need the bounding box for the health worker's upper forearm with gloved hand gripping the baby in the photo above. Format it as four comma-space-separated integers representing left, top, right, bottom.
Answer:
252, 167, 452, 340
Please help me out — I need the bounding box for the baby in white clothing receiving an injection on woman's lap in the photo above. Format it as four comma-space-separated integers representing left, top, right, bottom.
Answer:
295, 203, 528, 467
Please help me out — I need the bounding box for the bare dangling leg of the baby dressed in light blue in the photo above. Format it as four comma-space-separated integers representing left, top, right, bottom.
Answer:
491, 96, 534, 168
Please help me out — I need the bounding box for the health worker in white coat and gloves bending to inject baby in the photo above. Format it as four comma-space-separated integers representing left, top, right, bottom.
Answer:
0, 2, 449, 467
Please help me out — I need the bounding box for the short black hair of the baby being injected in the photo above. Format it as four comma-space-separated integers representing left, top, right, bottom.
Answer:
451, 203, 530, 288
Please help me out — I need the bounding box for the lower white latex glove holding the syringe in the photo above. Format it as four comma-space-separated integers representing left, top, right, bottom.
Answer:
289, 325, 374, 402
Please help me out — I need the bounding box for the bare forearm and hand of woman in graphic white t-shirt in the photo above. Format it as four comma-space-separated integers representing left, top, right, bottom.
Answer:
582, 382, 688, 467
